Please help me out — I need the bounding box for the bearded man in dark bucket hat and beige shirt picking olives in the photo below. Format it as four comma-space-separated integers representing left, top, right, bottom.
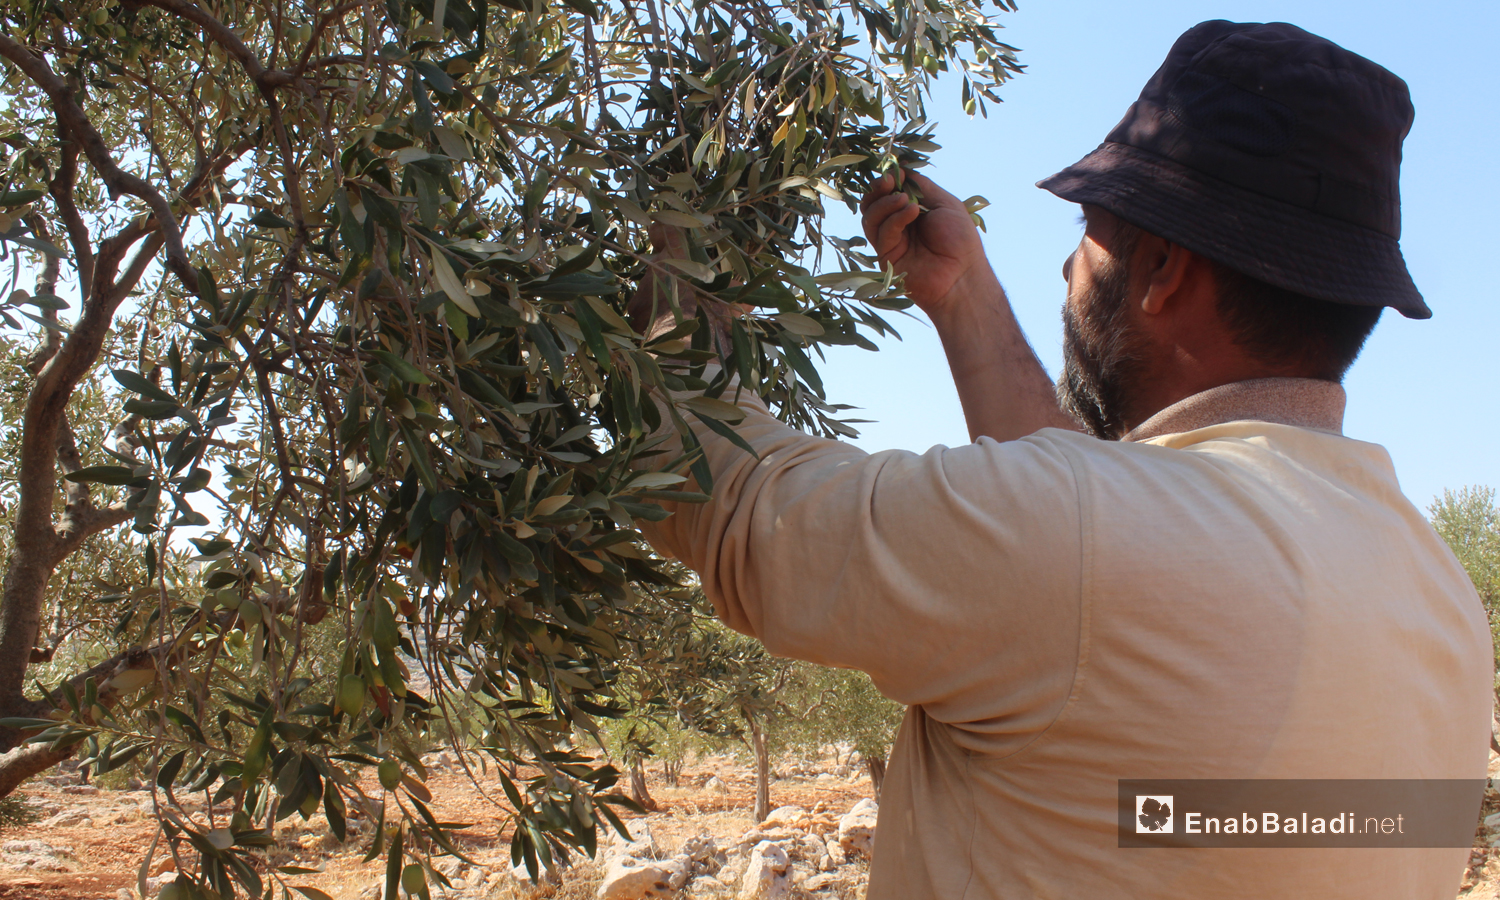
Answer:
639, 23, 1491, 900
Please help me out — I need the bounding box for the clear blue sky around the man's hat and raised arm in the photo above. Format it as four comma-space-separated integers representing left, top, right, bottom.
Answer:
825, 0, 1500, 509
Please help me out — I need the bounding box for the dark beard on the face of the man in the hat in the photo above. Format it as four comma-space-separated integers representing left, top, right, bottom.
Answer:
1058, 254, 1149, 441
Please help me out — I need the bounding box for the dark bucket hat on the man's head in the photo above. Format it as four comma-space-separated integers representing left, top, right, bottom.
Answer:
1037, 21, 1433, 318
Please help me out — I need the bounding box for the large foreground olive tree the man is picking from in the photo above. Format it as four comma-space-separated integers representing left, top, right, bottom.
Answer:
0, 0, 1016, 897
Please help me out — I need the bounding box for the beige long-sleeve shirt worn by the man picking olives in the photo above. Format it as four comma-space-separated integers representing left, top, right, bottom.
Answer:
639, 380, 1493, 900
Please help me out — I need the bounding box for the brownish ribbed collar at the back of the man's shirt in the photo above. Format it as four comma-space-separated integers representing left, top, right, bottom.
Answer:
1122, 378, 1347, 441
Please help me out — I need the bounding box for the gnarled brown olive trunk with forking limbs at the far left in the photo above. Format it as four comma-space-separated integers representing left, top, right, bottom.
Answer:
0, 35, 237, 797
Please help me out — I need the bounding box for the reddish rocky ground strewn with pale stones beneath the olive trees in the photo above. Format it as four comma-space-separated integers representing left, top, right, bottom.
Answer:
0, 744, 1500, 900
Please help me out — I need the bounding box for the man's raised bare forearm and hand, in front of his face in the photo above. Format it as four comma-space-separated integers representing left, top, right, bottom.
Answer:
864, 173, 1080, 441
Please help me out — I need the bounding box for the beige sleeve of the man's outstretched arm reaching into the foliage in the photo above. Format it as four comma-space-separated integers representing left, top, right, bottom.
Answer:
647, 382, 1082, 737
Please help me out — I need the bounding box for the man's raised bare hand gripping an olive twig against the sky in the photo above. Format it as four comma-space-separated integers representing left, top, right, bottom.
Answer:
861, 173, 989, 315
